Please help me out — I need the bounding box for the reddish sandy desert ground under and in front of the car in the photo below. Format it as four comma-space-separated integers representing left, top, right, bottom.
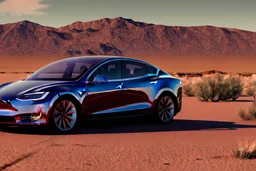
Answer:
0, 97, 256, 171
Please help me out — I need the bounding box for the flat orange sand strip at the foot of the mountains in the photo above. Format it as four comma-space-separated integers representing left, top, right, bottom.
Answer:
0, 54, 256, 73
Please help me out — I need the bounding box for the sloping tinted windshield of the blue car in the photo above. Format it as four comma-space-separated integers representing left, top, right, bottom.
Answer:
26, 58, 102, 81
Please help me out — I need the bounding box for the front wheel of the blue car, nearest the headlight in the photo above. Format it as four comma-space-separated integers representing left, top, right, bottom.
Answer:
51, 99, 78, 132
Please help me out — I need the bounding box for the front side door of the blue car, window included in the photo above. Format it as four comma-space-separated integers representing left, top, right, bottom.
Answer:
82, 61, 124, 115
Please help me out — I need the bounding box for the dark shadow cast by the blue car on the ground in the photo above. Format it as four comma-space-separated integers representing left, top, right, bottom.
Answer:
0, 118, 256, 135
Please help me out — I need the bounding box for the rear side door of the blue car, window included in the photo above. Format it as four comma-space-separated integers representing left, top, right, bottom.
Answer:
122, 60, 160, 110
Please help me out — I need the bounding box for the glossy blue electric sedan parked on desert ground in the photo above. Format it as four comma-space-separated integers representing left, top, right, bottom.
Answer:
0, 56, 182, 132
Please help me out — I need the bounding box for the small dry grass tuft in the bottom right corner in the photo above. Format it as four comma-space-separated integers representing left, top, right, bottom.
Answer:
234, 141, 256, 159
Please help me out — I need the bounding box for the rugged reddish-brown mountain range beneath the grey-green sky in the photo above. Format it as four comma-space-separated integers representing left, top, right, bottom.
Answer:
0, 17, 256, 57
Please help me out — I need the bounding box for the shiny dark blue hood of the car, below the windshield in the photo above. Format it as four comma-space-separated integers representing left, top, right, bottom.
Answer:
0, 80, 67, 100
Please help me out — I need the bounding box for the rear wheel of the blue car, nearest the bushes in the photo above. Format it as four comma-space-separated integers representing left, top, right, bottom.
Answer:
156, 95, 175, 123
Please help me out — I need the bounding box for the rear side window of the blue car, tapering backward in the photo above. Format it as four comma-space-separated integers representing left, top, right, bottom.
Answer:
122, 61, 157, 78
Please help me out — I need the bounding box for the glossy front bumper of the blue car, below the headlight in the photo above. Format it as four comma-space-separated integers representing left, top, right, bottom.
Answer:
0, 100, 50, 125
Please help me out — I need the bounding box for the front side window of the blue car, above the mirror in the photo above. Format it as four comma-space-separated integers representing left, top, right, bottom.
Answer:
89, 61, 121, 81
